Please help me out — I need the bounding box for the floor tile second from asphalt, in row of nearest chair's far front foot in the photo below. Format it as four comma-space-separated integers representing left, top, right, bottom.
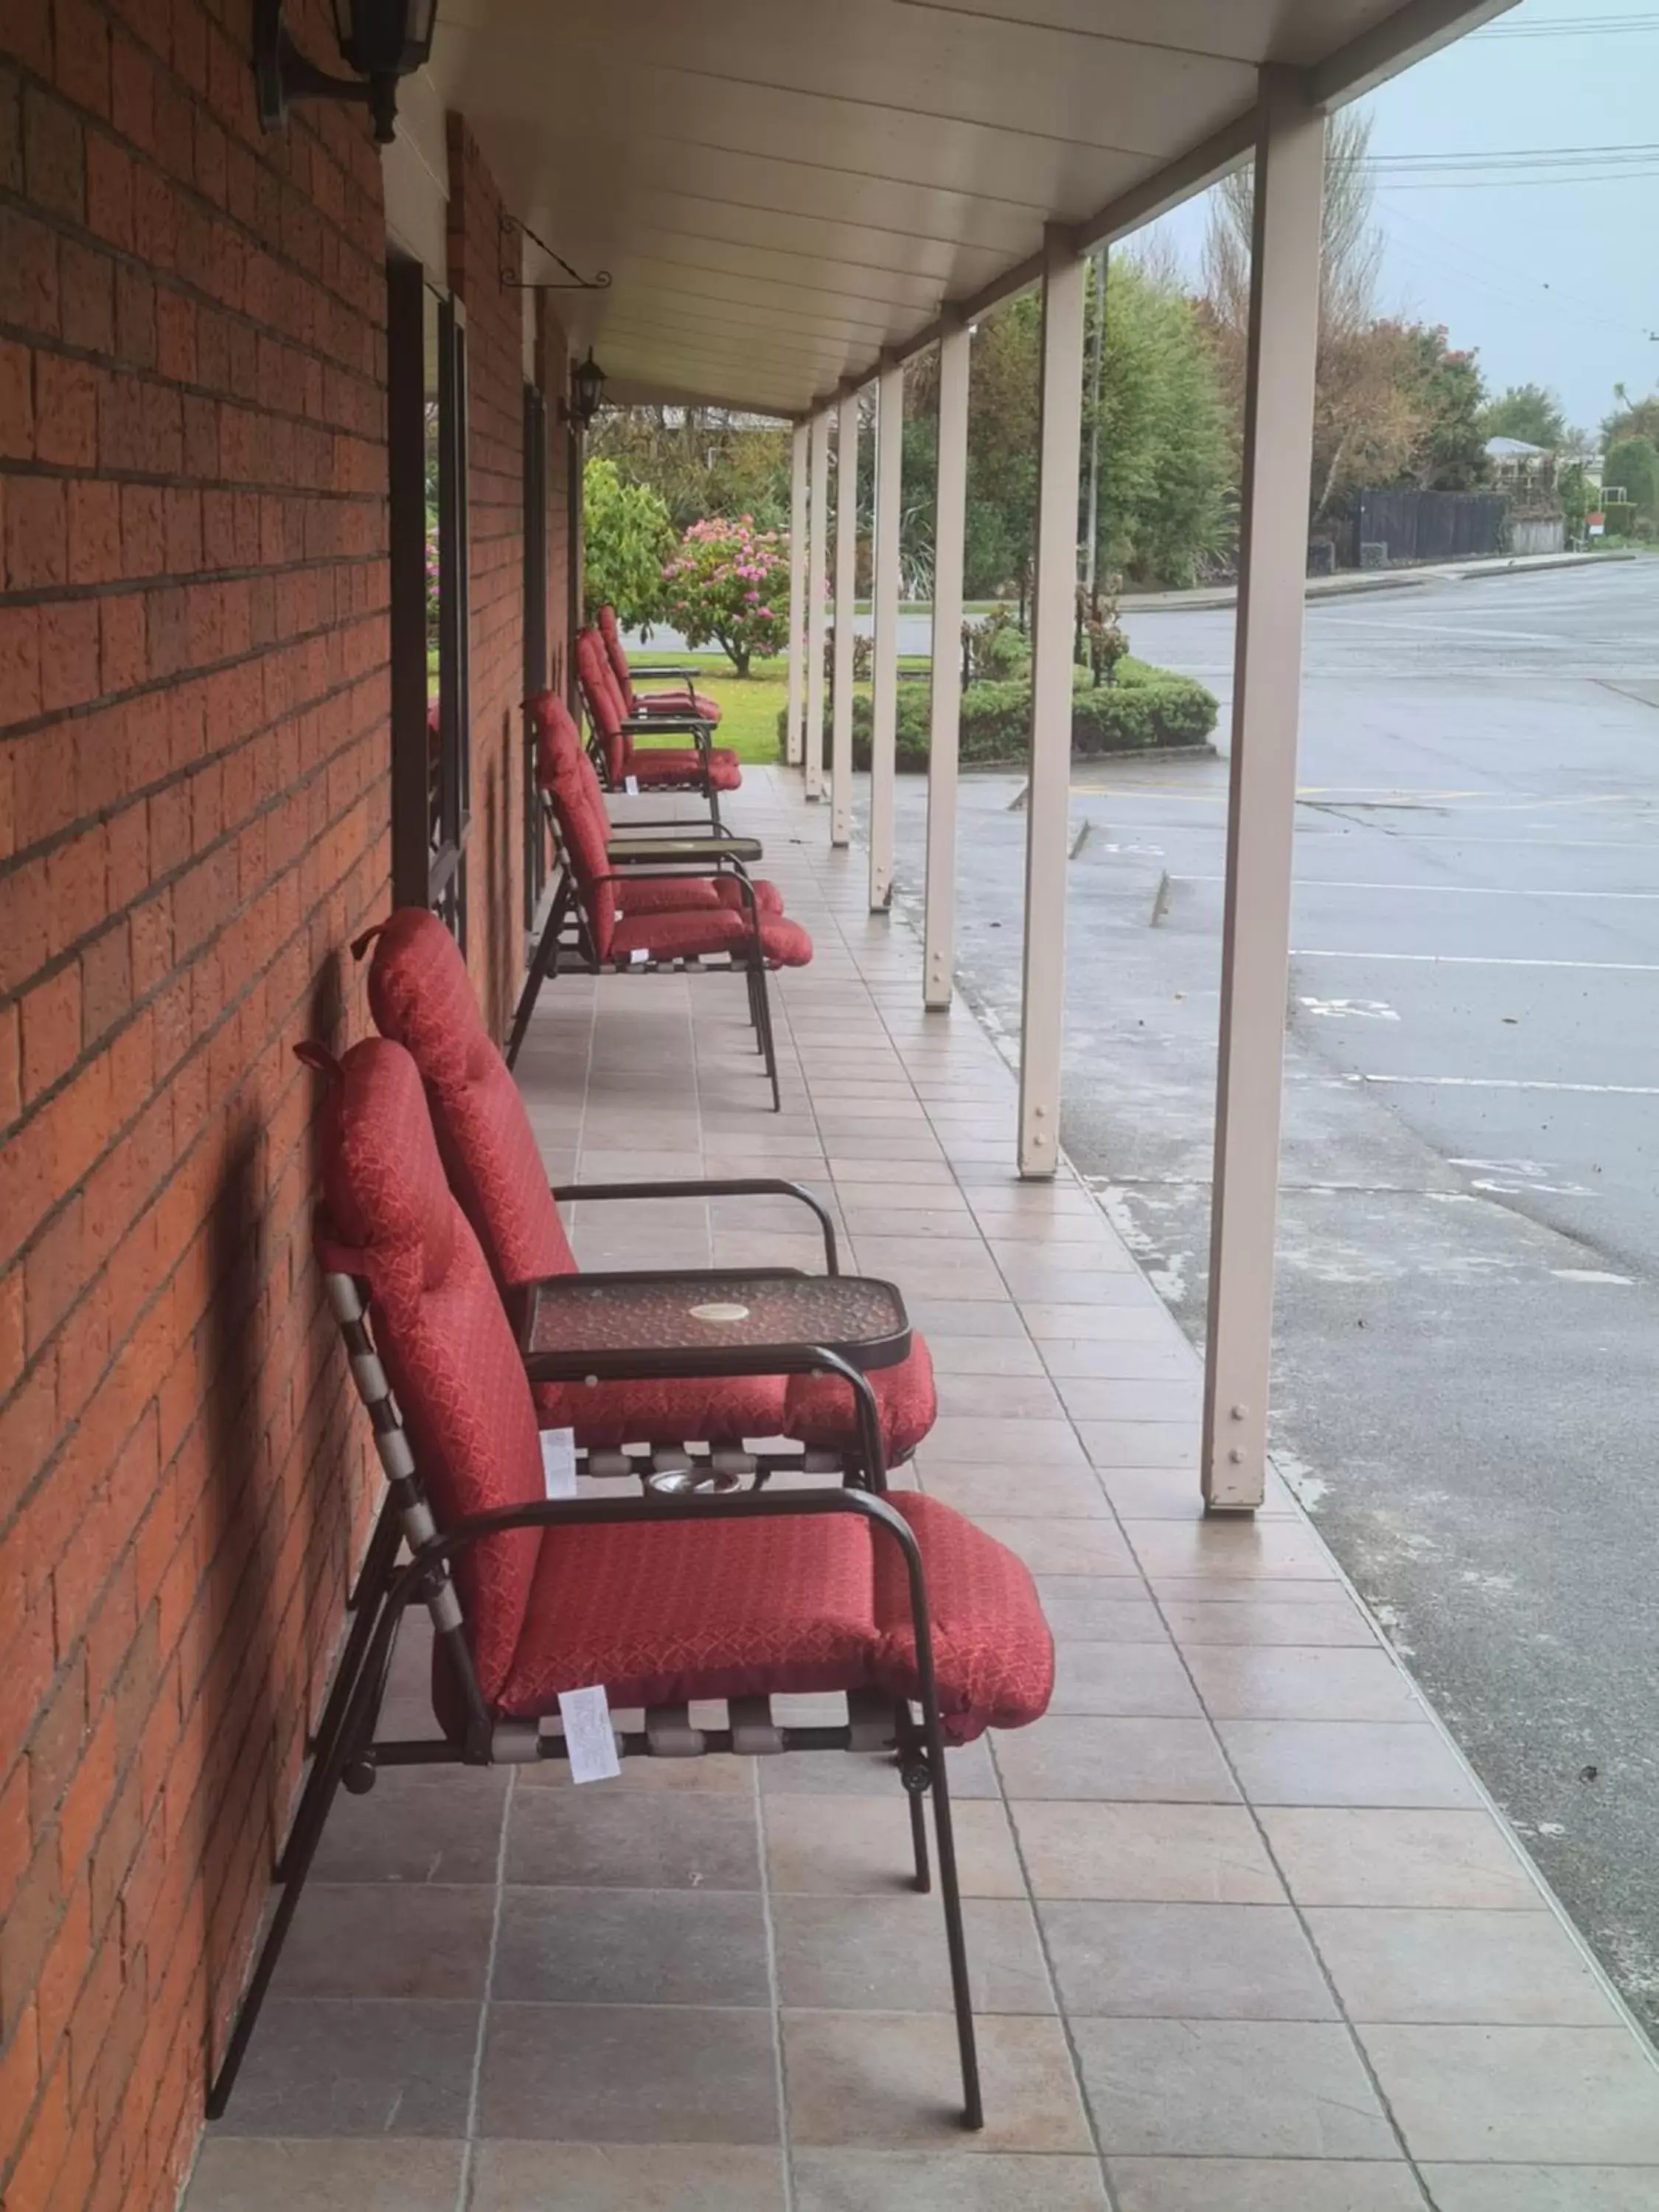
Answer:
1013, 1798, 1285, 1905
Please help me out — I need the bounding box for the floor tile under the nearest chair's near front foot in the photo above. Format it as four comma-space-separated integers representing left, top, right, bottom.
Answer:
783, 2013, 1093, 2152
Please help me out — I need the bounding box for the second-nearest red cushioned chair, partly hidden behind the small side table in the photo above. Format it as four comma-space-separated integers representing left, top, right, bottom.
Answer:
369, 907, 938, 1475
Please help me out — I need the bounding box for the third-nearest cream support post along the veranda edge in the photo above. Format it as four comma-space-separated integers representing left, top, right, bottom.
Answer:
922, 321, 973, 1006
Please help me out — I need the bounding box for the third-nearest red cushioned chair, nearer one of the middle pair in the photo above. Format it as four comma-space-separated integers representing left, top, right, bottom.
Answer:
507, 717, 812, 1113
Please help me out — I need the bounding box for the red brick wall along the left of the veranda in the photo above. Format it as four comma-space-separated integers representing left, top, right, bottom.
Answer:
0, 0, 571, 2212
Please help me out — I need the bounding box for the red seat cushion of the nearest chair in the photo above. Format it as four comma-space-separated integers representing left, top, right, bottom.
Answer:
502, 1495, 1053, 1743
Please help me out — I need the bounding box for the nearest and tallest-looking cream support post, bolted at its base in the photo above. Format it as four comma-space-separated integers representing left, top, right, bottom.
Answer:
1203, 69, 1325, 1513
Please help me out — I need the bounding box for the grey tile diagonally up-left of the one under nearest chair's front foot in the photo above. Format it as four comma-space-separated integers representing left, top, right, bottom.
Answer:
493, 1889, 770, 2004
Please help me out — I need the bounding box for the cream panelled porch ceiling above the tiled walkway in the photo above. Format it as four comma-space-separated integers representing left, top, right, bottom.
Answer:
431, 0, 1513, 414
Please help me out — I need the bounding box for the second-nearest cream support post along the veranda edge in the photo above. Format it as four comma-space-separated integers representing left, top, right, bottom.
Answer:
1020, 226, 1086, 1177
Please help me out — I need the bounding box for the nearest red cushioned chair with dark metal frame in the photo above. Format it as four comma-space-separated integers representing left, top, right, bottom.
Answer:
208, 1037, 1053, 2128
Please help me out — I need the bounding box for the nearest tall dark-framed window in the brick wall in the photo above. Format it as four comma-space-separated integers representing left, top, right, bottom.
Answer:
387, 261, 471, 947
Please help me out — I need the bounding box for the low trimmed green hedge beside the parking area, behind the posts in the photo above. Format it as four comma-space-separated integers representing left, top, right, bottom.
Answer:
779, 659, 1217, 774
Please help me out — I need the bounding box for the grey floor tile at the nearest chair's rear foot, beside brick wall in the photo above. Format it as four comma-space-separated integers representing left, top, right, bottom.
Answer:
217, 1997, 478, 2137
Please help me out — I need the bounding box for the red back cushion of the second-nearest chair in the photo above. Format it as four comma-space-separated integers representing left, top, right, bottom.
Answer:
369, 907, 575, 1287
